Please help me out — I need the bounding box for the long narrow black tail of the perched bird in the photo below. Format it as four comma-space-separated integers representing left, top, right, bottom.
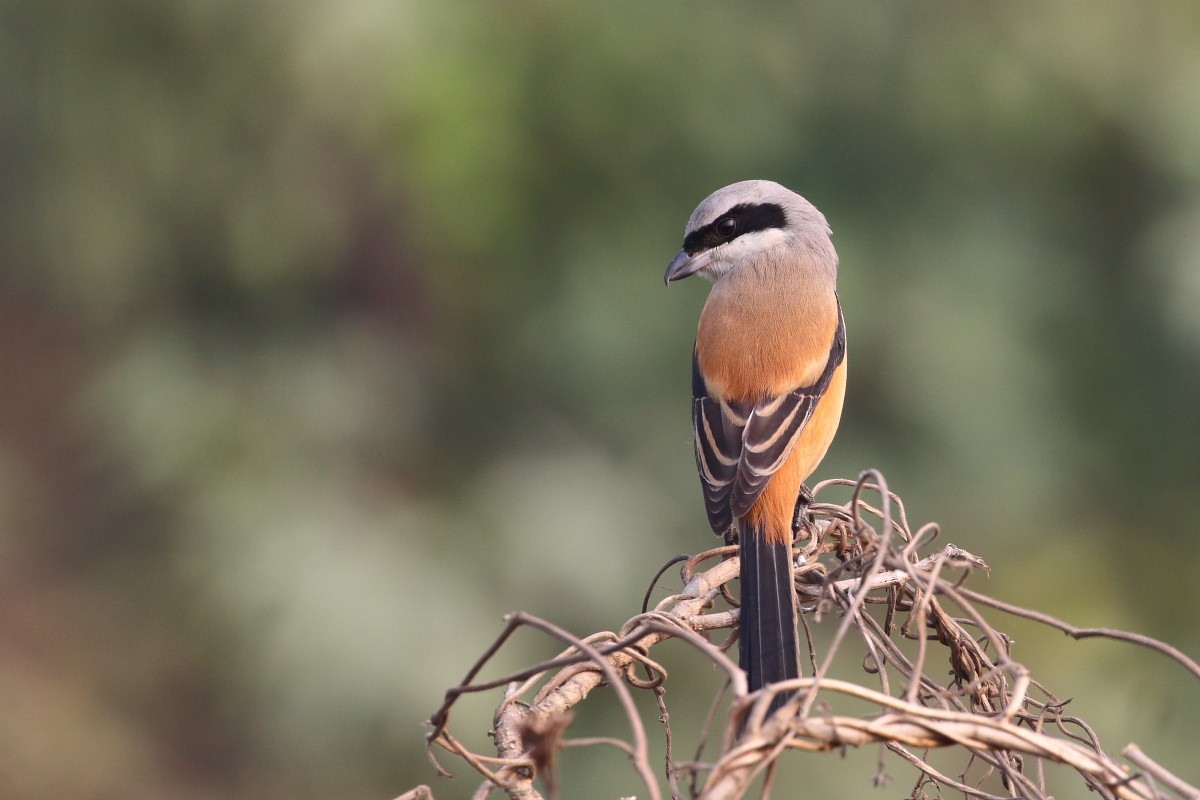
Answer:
738, 521, 800, 711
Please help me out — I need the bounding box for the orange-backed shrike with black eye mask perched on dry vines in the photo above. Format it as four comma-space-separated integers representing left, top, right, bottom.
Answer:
664, 180, 846, 711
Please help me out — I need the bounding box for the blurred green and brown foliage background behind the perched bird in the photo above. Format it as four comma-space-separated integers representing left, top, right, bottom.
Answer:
0, 0, 1200, 800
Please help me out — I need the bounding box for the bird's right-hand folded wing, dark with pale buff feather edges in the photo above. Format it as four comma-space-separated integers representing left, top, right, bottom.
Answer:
724, 303, 846, 518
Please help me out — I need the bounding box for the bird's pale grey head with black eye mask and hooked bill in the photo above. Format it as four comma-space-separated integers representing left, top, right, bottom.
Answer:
662, 181, 838, 283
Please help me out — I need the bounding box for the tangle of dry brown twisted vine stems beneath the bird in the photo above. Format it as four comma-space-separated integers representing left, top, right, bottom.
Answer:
415, 471, 1200, 800
